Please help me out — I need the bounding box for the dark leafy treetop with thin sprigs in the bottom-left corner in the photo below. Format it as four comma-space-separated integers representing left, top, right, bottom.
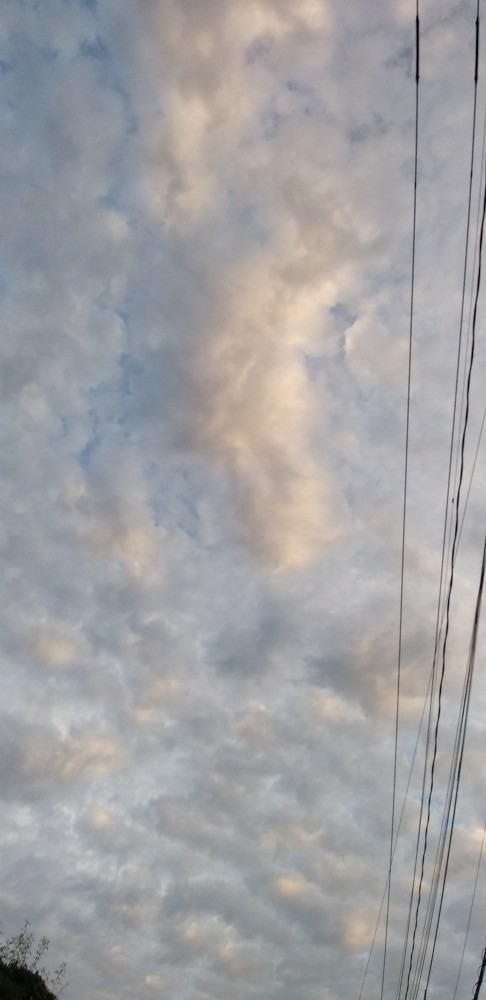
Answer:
0, 920, 66, 1000
